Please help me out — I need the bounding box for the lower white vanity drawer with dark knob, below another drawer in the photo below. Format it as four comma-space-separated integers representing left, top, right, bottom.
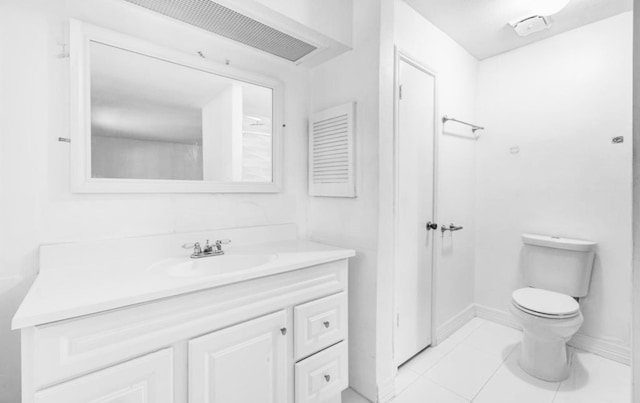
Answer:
295, 341, 349, 403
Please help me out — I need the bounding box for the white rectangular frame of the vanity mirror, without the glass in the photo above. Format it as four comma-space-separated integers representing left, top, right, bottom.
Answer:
69, 19, 284, 193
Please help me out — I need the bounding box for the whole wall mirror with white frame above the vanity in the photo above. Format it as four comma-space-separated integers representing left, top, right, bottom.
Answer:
71, 21, 282, 193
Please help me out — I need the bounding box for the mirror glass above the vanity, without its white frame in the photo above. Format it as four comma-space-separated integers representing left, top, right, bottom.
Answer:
90, 42, 273, 182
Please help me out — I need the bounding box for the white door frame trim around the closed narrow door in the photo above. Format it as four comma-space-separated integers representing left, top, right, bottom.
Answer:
392, 46, 441, 367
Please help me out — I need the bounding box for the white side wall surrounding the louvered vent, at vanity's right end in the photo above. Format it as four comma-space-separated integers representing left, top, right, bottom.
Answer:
308, 0, 380, 400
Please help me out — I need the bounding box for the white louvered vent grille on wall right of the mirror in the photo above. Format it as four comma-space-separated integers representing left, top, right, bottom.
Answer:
309, 103, 355, 197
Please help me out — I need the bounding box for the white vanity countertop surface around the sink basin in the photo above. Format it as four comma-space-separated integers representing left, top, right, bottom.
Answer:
12, 240, 355, 329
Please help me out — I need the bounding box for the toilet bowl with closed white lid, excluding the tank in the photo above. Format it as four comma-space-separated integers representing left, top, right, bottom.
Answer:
511, 288, 584, 382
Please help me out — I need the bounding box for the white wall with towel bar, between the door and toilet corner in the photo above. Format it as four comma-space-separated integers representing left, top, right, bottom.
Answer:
395, 0, 478, 334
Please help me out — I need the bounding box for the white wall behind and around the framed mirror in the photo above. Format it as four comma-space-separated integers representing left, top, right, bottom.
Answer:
0, 0, 308, 402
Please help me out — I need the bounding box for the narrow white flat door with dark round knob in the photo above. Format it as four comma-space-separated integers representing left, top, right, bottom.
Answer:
394, 59, 436, 365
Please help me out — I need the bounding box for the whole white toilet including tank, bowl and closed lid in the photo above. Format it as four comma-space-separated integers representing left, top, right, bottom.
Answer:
511, 234, 596, 382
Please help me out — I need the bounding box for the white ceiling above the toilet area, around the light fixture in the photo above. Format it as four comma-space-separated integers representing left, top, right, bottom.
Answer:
405, 0, 633, 60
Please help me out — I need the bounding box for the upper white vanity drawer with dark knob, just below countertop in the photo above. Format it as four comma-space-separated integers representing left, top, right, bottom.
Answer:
294, 292, 348, 361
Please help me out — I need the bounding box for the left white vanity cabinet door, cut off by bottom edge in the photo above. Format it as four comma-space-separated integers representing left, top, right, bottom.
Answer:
35, 348, 173, 403
